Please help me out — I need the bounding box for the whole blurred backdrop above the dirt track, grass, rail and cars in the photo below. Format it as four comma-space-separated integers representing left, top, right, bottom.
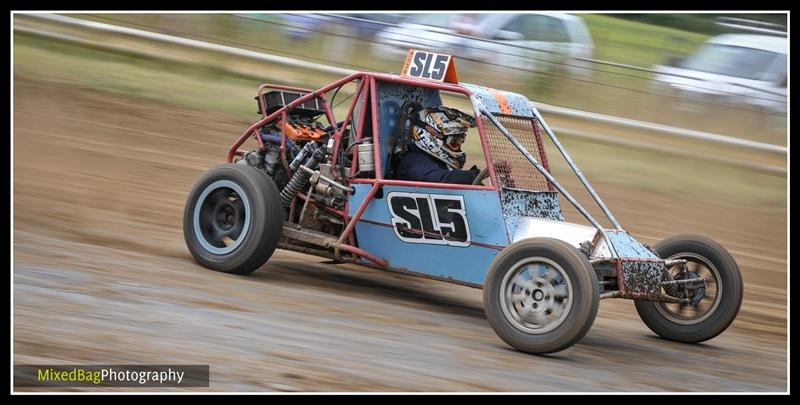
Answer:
14, 13, 788, 202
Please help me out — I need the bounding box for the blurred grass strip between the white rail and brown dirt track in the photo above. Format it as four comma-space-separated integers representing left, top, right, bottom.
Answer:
14, 34, 787, 207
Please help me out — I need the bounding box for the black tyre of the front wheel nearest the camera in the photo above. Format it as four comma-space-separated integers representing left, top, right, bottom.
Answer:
483, 238, 599, 354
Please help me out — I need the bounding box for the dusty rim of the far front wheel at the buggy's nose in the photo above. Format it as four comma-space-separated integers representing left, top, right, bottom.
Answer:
655, 252, 723, 325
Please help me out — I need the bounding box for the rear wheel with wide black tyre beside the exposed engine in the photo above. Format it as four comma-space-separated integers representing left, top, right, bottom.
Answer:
183, 164, 285, 274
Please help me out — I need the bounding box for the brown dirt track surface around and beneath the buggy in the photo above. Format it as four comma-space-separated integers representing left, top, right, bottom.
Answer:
13, 77, 787, 391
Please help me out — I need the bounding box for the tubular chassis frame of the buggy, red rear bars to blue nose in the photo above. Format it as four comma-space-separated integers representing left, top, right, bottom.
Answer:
227, 72, 707, 303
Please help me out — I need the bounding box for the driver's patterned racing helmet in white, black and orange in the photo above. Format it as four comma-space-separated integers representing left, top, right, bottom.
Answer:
411, 106, 475, 169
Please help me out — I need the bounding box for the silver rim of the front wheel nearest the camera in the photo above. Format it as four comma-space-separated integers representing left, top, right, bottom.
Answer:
500, 257, 573, 335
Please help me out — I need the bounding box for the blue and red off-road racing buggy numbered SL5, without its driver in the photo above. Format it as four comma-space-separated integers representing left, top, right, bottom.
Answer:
183, 50, 743, 353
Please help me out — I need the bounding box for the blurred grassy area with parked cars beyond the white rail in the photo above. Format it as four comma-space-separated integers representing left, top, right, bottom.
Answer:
20, 13, 788, 131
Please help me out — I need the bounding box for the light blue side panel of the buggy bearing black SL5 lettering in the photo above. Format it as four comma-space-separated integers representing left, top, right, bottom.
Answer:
349, 184, 509, 285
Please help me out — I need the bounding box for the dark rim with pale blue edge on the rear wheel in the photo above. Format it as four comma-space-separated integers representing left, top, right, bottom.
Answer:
193, 180, 250, 255
